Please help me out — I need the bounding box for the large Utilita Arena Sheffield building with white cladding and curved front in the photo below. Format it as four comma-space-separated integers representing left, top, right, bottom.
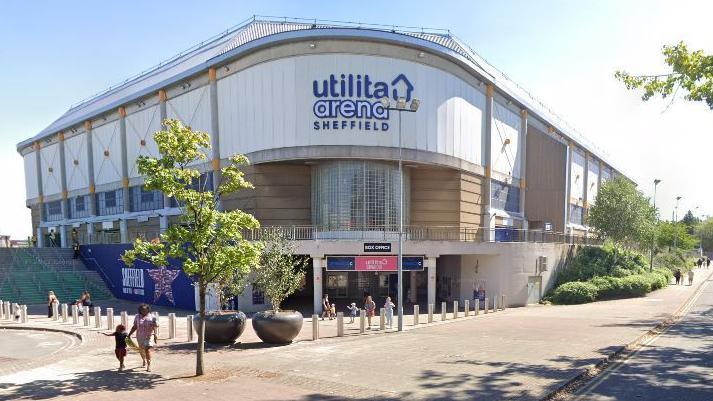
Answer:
17, 18, 620, 310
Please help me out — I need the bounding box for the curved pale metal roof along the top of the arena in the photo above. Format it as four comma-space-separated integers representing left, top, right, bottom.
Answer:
17, 16, 621, 175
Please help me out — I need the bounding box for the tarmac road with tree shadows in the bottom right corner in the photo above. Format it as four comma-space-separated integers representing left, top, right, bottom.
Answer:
575, 279, 713, 401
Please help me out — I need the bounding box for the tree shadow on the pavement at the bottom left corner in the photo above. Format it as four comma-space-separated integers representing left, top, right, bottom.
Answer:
0, 369, 161, 401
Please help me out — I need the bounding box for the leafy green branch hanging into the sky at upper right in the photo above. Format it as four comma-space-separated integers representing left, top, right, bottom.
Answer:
615, 42, 713, 109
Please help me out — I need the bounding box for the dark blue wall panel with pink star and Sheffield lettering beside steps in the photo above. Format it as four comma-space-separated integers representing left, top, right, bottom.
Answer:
80, 244, 196, 310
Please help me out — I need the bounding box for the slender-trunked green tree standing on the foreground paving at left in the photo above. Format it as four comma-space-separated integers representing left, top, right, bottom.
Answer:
122, 119, 262, 375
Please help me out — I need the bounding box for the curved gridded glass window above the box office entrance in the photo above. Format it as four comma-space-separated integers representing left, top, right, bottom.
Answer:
312, 160, 410, 231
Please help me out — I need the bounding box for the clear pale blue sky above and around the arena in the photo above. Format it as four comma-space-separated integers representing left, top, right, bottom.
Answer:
0, 0, 713, 237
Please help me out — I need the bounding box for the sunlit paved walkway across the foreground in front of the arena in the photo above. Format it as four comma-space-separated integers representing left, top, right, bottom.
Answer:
0, 270, 710, 401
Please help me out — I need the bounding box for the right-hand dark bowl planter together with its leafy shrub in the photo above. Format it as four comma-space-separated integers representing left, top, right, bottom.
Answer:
252, 230, 308, 344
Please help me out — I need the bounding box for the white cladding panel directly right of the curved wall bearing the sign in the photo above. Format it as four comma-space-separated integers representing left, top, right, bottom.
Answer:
490, 102, 522, 178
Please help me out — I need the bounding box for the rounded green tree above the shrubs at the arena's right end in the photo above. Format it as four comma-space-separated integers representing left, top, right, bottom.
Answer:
587, 177, 656, 249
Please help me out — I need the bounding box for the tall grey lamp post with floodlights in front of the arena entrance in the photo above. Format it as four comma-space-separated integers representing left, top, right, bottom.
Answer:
380, 97, 421, 331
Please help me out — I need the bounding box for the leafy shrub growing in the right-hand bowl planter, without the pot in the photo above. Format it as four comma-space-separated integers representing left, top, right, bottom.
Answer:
255, 229, 308, 313
